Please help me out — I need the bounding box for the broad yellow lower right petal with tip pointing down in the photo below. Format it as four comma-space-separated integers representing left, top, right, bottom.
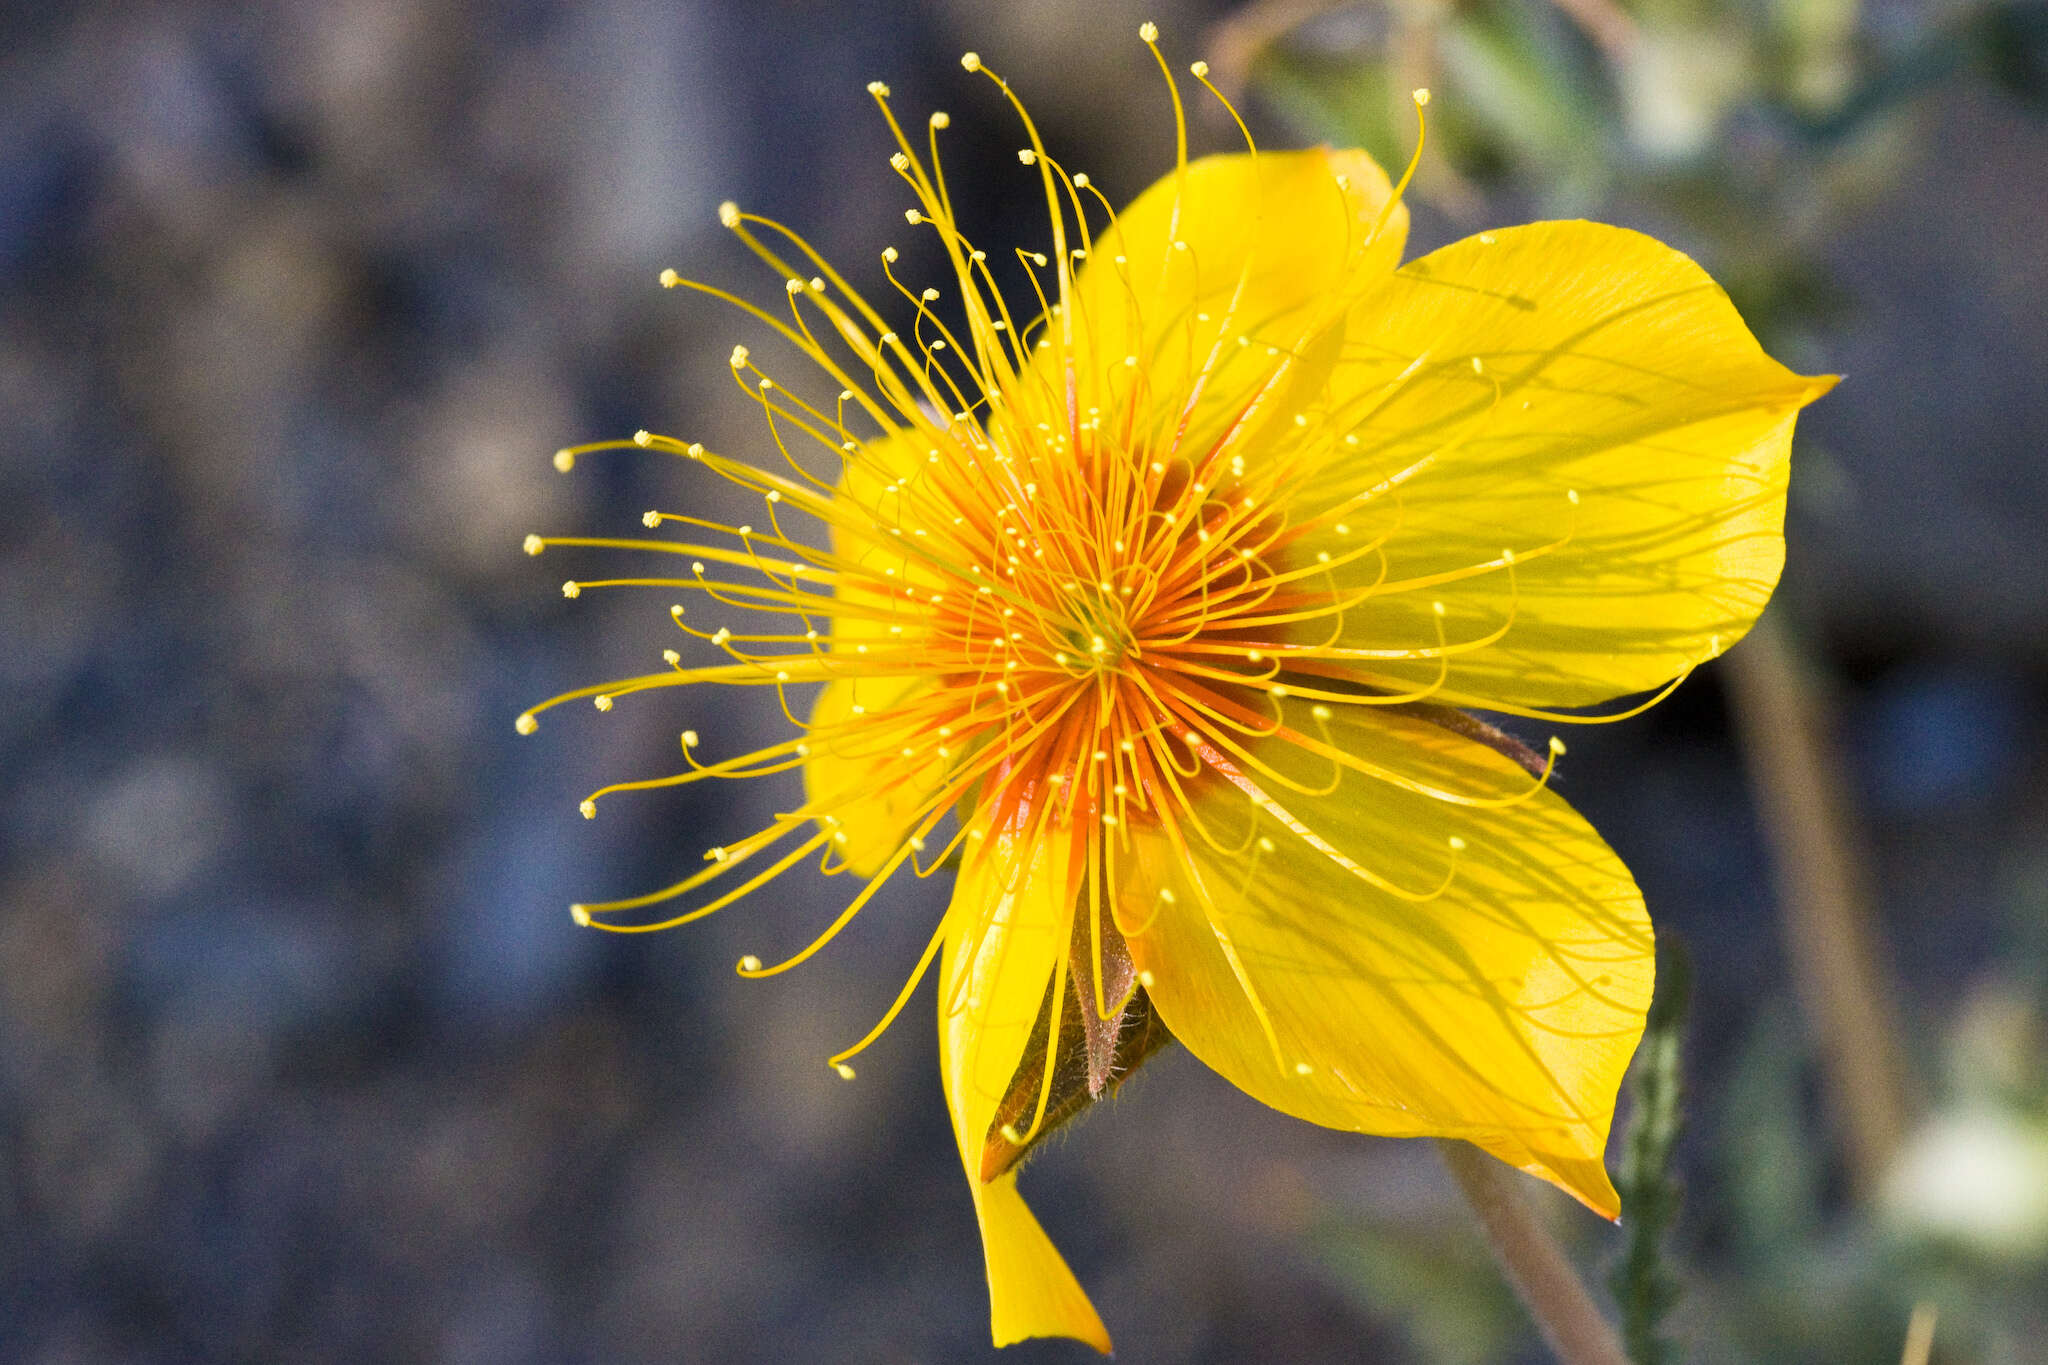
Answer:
1118, 702, 1653, 1218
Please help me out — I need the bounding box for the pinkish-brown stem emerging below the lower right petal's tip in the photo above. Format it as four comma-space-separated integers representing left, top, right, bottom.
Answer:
1436, 1138, 1628, 1365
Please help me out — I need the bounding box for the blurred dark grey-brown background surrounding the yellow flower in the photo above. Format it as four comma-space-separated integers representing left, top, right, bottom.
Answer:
0, 0, 2048, 1365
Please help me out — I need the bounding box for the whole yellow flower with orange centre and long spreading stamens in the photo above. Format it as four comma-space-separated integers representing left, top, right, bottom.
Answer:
520, 27, 1831, 1349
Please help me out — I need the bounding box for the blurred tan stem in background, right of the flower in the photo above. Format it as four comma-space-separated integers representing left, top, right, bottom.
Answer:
1726, 612, 1913, 1197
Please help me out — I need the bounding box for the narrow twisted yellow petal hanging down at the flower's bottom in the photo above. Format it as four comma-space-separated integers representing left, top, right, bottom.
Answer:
938, 814, 1110, 1353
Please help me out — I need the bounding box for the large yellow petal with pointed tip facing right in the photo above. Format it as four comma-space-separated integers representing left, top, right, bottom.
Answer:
1294, 223, 1833, 706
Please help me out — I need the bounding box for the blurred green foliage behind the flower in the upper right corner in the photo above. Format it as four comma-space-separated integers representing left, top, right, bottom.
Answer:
1249, 0, 2048, 346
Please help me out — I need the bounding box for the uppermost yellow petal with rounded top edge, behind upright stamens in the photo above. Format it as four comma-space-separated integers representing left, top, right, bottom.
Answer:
1034, 147, 1407, 448
